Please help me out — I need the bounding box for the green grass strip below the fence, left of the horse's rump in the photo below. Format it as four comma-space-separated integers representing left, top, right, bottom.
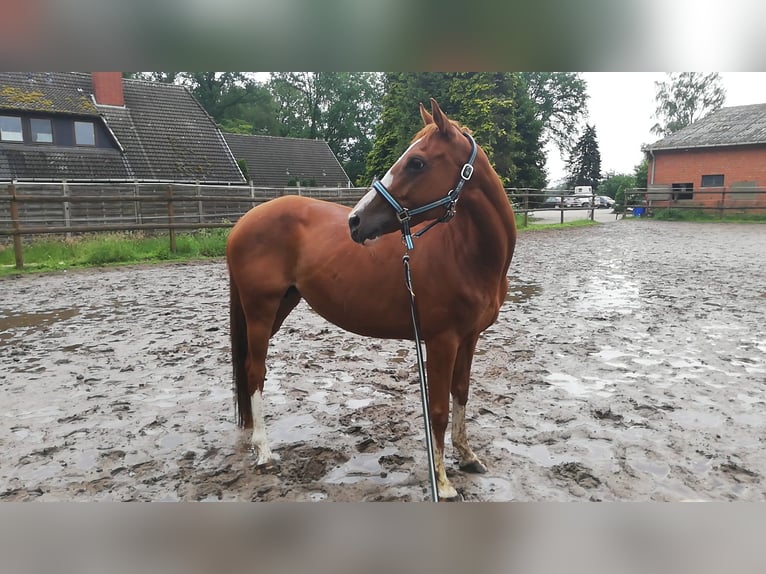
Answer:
0, 229, 229, 275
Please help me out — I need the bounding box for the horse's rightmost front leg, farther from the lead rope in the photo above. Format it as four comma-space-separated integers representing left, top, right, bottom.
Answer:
451, 336, 487, 473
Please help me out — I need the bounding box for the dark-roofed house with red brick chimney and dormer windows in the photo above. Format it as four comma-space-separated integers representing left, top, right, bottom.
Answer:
0, 72, 245, 184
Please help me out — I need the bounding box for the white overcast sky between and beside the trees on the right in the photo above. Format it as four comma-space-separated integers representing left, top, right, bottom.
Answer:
546, 72, 766, 187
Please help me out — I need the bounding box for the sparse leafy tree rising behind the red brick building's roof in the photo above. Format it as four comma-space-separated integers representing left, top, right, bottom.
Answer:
652, 72, 726, 136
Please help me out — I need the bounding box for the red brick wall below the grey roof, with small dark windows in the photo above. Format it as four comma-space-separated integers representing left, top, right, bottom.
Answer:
648, 145, 766, 207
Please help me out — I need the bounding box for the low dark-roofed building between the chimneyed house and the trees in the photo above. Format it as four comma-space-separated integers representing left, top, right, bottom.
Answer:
224, 134, 351, 188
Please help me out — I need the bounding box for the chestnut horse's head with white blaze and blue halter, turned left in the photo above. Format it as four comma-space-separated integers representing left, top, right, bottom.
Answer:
348, 98, 476, 248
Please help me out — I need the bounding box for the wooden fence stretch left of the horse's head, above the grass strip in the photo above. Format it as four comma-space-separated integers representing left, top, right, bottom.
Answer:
0, 181, 367, 268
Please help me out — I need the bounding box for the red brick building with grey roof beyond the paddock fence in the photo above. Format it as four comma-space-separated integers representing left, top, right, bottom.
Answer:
643, 104, 766, 209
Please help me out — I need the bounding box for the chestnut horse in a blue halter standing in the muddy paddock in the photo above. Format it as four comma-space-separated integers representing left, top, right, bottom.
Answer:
226, 100, 516, 499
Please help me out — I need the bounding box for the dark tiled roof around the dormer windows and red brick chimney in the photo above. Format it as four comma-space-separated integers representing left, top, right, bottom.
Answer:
0, 72, 244, 183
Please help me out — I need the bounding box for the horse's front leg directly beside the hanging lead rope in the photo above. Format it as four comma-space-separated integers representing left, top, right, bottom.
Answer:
426, 337, 459, 500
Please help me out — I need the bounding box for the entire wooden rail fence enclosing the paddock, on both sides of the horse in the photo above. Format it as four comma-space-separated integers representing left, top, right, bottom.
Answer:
0, 181, 766, 268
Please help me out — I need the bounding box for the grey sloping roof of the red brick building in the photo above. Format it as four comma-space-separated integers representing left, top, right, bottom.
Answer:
644, 104, 766, 151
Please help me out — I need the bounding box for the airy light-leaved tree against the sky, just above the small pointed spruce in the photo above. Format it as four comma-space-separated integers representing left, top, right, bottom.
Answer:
521, 72, 588, 157
